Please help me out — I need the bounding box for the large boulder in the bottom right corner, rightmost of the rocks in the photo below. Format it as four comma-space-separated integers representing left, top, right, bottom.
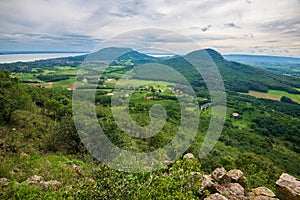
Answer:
276, 173, 300, 200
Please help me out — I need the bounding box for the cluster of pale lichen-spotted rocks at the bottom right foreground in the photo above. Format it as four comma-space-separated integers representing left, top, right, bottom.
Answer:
199, 168, 290, 200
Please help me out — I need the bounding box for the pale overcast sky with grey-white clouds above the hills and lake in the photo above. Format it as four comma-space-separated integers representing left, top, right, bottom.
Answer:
0, 0, 300, 57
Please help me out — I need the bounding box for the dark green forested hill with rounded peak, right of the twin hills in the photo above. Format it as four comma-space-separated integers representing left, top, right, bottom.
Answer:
161, 49, 300, 94
